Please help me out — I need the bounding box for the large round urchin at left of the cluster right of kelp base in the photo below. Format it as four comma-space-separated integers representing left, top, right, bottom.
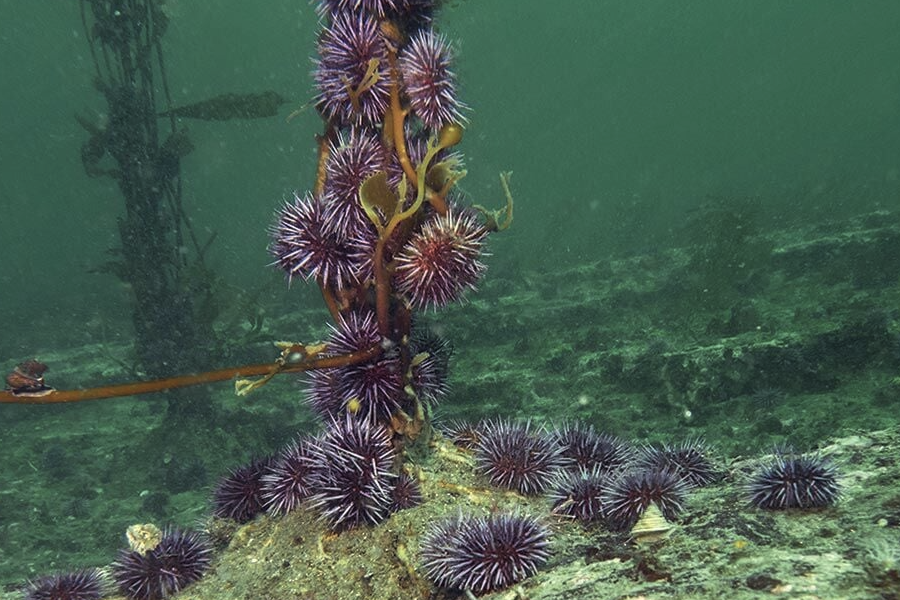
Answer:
475, 419, 566, 495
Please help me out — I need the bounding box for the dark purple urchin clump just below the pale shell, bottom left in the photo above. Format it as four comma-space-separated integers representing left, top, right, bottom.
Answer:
112, 530, 212, 600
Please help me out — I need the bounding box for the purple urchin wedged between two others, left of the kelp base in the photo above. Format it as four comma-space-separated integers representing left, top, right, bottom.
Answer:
262, 439, 315, 515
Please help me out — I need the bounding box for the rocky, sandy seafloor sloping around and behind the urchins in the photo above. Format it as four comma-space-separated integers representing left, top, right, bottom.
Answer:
0, 212, 900, 600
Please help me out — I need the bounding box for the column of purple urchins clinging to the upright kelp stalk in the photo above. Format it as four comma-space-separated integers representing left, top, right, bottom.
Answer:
271, 0, 488, 430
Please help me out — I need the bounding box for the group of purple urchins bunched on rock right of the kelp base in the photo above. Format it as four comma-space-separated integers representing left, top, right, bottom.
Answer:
454, 419, 717, 531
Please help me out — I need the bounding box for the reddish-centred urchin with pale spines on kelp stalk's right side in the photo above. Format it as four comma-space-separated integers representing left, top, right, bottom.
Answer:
394, 207, 487, 308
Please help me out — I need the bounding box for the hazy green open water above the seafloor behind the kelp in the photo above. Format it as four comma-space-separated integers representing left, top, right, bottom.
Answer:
0, 0, 900, 358
